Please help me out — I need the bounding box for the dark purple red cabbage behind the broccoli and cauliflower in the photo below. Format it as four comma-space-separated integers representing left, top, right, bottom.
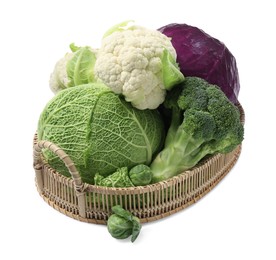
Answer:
159, 23, 240, 103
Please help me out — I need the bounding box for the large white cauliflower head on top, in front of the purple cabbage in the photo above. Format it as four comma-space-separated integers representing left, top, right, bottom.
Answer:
94, 22, 184, 109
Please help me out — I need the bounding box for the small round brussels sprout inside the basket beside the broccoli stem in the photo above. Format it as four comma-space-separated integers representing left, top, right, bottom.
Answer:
129, 164, 152, 186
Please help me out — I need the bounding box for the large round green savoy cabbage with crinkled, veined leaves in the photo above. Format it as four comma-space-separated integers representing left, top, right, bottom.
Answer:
38, 83, 164, 183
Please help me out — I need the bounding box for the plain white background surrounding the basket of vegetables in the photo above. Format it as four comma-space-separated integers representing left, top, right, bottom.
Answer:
0, 0, 276, 260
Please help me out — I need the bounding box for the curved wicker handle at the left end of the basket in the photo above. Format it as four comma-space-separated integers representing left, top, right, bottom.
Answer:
33, 141, 86, 218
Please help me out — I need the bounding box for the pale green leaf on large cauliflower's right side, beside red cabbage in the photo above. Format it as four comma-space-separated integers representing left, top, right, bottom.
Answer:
161, 49, 184, 90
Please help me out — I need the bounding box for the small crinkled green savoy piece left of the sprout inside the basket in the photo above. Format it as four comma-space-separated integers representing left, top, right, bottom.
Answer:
94, 167, 134, 187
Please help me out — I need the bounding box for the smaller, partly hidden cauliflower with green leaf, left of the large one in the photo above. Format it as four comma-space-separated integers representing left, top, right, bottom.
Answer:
50, 44, 96, 93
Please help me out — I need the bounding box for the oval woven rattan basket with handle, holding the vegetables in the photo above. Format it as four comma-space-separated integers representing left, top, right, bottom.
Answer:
34, 104, 244, 224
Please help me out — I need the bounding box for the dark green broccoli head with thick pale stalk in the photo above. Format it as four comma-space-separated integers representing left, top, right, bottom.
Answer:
150, 77, 244, 183
